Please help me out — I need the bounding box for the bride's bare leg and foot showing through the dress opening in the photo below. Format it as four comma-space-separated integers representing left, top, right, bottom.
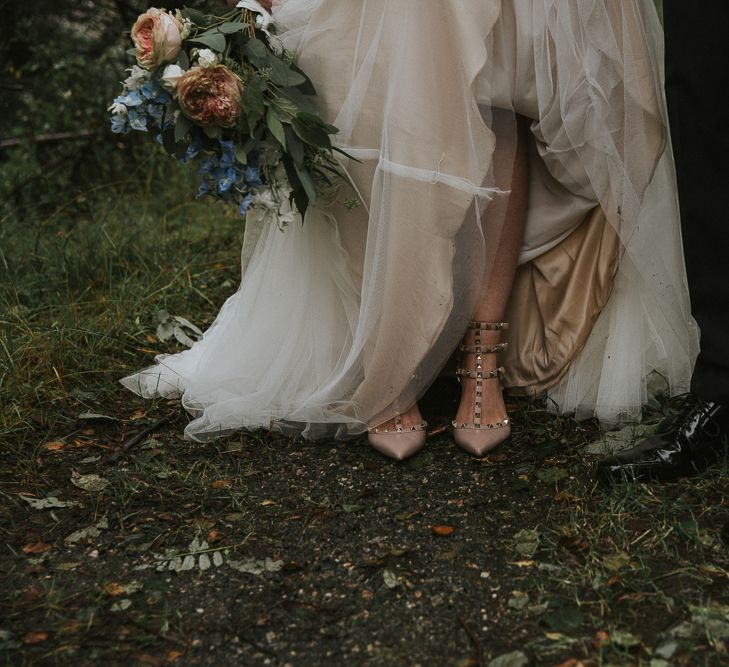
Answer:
456, 109, 529, 423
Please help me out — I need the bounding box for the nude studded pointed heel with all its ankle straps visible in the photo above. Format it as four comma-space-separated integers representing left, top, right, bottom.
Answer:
453, 322, 511, 457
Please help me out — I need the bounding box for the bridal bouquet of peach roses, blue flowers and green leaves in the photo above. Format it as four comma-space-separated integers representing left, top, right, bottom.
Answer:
109, 0, 343, 226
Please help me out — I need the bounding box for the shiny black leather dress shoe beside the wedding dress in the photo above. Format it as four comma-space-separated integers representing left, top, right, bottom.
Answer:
597, 394, 729, 482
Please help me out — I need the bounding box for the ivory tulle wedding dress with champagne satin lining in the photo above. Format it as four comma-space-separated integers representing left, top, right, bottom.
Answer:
122, 0, 698, 440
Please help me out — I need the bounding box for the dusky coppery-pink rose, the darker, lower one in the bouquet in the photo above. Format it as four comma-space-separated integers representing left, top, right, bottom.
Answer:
177, 65, 243, 127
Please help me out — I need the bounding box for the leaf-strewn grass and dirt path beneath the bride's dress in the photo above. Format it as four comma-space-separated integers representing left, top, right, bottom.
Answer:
0, 162, 729, 667
